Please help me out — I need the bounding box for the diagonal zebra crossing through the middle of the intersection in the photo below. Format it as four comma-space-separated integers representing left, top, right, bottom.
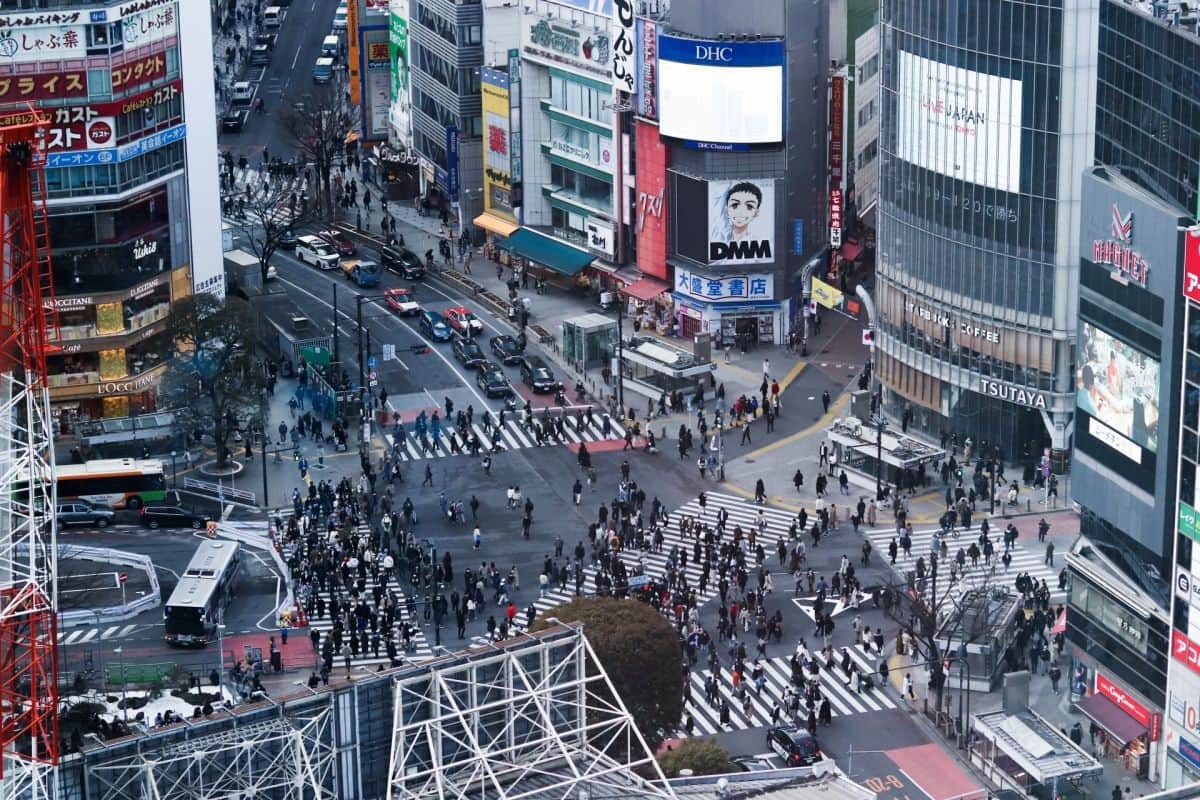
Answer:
515, 492, 793, 630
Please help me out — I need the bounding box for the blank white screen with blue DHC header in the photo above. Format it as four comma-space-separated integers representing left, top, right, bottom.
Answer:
658, 35, 784, 145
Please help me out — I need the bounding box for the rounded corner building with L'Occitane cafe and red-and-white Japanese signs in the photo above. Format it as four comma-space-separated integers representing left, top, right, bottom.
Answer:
0, 0, 224, 427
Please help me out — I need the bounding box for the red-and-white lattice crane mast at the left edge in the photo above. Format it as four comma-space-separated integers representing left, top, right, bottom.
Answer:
0, 108, 59, 800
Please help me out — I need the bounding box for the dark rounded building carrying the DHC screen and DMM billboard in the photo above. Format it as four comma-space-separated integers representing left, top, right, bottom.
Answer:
652, 0, 830, 347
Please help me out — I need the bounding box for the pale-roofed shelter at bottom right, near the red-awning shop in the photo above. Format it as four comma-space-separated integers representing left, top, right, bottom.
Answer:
970, 709, 1104, 800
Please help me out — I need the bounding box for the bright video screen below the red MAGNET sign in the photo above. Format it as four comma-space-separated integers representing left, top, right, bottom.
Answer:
1075, 323, 1159, 461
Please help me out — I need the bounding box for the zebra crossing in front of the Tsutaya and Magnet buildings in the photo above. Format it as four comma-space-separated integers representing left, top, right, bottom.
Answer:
866, 527, 1063, 602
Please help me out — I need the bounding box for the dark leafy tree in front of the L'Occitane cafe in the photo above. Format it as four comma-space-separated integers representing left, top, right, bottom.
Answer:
163, 294, 266, 468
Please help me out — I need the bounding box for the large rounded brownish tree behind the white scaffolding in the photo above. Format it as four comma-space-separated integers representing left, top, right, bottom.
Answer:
533, 597, 683, 750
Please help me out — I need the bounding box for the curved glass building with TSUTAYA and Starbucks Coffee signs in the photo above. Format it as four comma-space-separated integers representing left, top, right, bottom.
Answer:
876, 0, 1099, 459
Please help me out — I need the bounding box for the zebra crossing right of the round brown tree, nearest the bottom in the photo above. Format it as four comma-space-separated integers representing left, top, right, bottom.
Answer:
679, 643, 900, 735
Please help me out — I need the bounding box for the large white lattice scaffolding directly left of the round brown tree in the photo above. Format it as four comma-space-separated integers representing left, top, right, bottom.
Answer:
388, 626, 674, 800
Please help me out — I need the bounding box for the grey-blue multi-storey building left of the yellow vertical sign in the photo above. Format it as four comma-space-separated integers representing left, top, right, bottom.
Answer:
396, 0, 484, 221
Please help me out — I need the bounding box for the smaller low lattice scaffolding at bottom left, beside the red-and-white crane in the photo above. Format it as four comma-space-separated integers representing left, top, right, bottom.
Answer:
88, 709, 337, 800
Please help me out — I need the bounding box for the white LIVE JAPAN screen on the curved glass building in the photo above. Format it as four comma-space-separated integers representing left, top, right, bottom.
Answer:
896, 50, 1021, 192
